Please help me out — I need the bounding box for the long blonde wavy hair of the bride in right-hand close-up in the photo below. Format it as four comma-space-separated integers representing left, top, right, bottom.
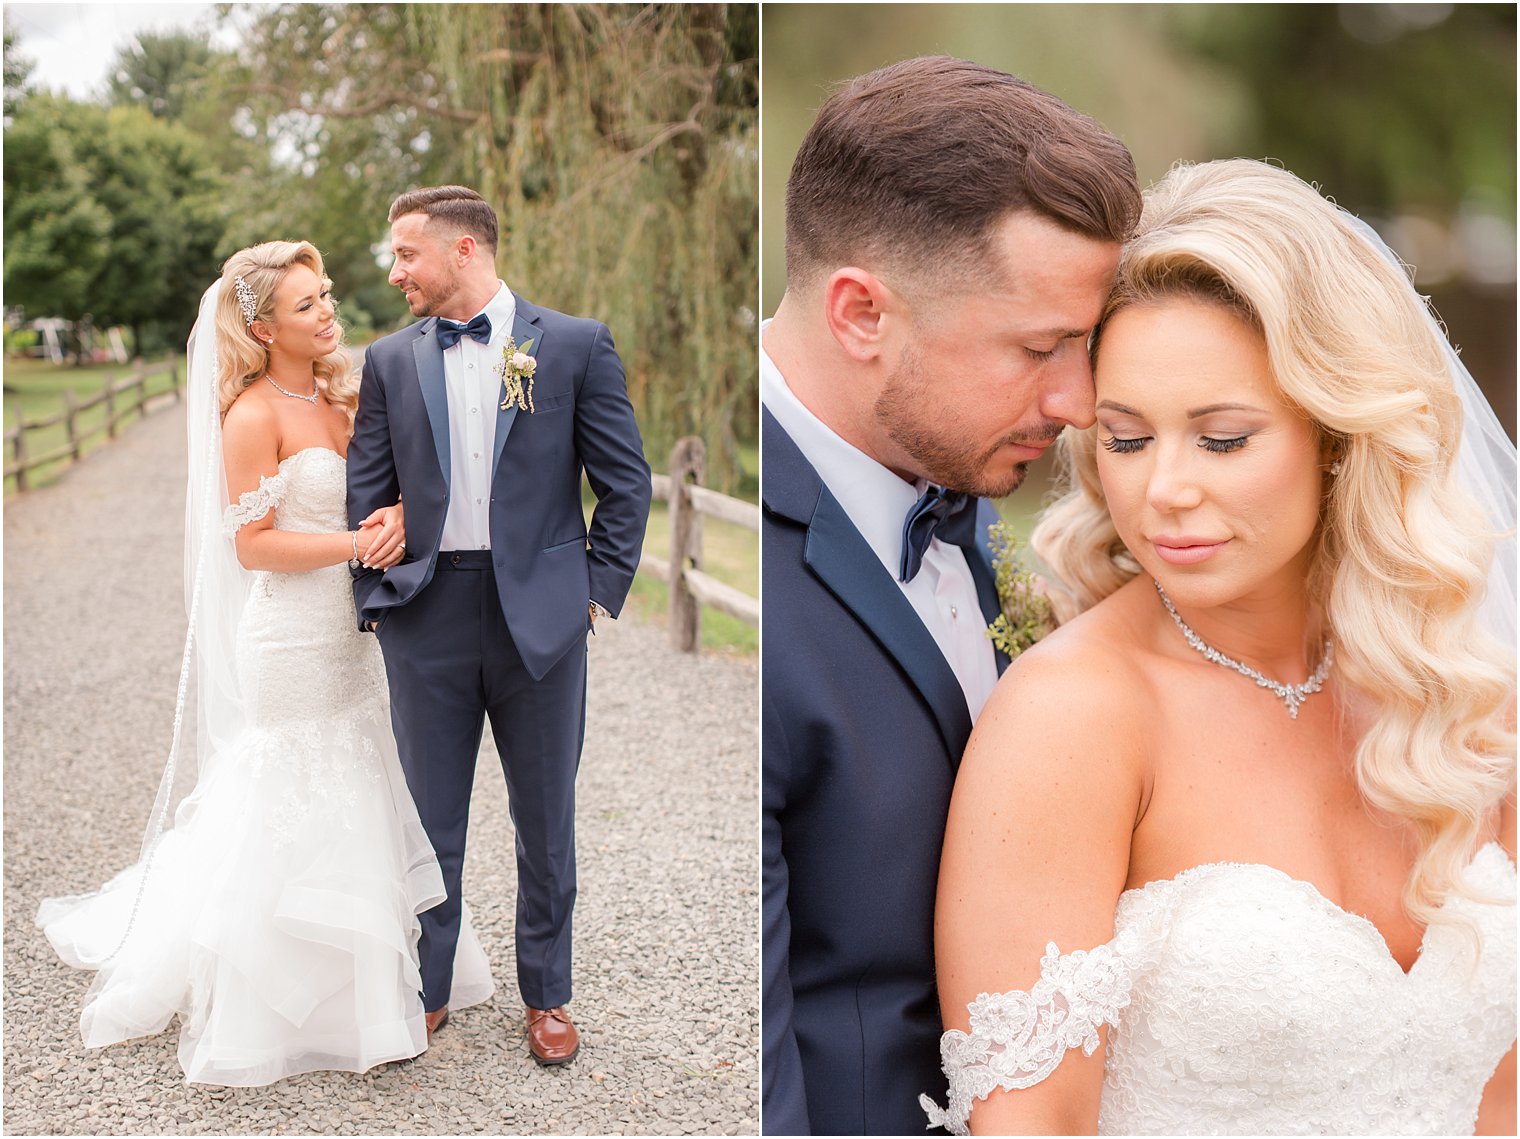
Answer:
1031, 160, 1515, 923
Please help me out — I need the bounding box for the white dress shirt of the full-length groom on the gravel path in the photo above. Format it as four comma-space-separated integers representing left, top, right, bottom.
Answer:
439, 284, 517, 550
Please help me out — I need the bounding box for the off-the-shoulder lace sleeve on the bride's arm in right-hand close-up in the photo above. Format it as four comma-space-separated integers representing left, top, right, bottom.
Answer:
918, 938, 1132, 1134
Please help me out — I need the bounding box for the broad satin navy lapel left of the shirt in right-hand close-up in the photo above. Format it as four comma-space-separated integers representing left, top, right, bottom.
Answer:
762, 412, 971, 766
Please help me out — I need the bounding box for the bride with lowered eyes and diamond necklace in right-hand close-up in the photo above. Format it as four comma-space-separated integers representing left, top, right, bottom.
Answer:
924, 161, 1515, 1134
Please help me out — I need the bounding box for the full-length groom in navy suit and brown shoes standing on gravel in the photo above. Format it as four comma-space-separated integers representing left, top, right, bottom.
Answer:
348, 186, 651, 1064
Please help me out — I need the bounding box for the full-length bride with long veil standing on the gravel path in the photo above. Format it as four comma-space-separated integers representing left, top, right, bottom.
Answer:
38, 242, 491, 1086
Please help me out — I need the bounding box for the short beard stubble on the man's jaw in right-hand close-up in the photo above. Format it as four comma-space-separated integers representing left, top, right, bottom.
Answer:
874, 340, 1066, 499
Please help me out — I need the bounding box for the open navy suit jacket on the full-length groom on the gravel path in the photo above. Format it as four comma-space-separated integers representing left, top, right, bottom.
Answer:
348, 297, 651, 680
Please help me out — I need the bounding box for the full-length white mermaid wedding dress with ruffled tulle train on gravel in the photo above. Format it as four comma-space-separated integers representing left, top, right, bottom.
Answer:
38, 447, 492, 1086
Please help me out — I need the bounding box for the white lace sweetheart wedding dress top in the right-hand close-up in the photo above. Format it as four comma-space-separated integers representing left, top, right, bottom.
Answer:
921, 842, 1515, 1134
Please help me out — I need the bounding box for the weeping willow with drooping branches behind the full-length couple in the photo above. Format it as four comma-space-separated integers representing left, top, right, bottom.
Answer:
221, 3, 758, 477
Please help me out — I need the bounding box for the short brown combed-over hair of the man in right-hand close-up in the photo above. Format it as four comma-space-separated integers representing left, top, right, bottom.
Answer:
786, 56, 1142, 293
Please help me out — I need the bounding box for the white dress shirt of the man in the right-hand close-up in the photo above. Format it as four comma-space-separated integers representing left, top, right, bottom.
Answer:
760, 321, 997, 721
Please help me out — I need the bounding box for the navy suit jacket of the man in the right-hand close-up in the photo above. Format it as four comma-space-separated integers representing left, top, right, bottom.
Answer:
762, 412, 1002, 1134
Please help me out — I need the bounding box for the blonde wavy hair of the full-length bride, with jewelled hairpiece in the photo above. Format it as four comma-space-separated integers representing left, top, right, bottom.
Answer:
216, 242, 359, 429
